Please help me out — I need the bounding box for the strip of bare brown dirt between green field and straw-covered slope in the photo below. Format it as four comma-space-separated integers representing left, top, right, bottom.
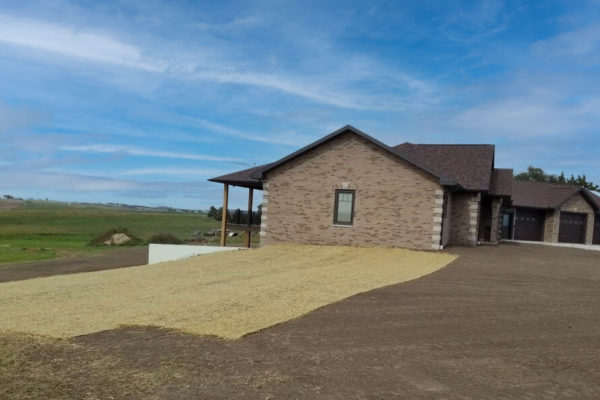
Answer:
0, 246, 148, 283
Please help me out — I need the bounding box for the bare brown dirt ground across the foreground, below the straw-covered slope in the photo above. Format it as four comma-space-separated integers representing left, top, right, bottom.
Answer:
0, 245, 600, 400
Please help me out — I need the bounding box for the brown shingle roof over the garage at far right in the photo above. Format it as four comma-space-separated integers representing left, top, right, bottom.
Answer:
512, 180, 600, 210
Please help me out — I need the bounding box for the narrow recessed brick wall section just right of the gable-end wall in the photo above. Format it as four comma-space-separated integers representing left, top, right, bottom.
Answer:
449, 192, 481, 246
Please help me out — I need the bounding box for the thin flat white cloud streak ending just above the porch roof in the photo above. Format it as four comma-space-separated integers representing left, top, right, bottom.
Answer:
59, 144, 243, 164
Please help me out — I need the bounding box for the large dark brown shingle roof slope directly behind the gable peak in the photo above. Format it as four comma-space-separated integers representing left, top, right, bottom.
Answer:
393, 143, 494, 191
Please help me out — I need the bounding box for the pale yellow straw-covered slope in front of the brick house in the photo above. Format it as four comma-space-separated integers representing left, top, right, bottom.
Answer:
0, 245, 456, 339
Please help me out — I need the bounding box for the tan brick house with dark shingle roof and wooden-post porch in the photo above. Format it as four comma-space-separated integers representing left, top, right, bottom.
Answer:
210, 126, 600, 250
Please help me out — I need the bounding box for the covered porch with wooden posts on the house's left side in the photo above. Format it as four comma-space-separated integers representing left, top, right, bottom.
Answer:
209, 163, 263, 248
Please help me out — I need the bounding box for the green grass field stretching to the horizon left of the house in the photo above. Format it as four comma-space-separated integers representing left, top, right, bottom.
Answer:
0, 200, 225, 263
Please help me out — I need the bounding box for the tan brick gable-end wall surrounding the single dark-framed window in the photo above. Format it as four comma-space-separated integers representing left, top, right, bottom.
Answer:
261, 133, 443, 249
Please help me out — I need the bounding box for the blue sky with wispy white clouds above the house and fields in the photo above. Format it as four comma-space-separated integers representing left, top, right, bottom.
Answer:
0, 0, 600, 209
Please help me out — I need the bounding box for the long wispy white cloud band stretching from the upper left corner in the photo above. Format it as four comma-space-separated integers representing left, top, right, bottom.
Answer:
0, 14, 433, 110
